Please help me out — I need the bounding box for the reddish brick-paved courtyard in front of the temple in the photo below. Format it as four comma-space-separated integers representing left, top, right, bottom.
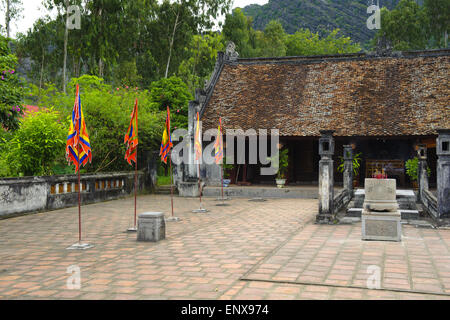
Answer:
0, 195, 450, 300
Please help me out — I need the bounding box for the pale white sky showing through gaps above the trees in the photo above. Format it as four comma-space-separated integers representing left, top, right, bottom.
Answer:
0, 0, 269, 37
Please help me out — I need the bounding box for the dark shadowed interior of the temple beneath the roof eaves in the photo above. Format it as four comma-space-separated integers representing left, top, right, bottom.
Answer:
230, 137, 437, 188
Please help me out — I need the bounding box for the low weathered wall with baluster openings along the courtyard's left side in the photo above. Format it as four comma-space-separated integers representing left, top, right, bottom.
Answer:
0, 171, 148, 217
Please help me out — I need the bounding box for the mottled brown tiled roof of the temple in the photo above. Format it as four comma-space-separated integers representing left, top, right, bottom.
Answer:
202, 50, 450, 136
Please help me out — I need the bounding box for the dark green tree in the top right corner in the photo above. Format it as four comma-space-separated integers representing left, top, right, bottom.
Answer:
424, 0, 450, 48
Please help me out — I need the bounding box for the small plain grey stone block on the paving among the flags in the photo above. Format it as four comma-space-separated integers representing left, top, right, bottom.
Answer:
137, 212, 166, 242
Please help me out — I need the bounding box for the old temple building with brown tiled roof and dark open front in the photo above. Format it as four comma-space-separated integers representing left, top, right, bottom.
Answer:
182, 43, 450, 188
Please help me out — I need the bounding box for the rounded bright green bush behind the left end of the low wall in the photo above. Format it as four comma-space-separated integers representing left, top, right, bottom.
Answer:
0, 110, 68, 176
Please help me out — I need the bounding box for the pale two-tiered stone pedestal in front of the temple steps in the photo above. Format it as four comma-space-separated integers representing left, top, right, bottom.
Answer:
361, 179, 402, 241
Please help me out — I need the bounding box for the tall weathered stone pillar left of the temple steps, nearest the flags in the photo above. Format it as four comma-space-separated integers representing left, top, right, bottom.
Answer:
316, 130, 334, 223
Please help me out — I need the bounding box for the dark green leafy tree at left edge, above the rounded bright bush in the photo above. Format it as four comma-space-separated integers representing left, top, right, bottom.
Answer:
0, 35, 24, 130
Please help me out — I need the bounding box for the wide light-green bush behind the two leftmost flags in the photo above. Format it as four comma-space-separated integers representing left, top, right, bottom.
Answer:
23, 75, 176, 173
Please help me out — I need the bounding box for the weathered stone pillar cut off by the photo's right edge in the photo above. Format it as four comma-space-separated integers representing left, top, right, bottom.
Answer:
436, 129, 450, 218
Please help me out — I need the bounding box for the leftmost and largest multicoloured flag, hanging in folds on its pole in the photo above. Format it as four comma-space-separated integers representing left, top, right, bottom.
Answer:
66, 85, 92, 172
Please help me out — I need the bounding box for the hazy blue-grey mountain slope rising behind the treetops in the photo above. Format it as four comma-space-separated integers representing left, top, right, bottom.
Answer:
243, 0, 400, 44
